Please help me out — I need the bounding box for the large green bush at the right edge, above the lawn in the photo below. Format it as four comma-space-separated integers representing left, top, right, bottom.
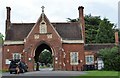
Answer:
98, 46, 120, 71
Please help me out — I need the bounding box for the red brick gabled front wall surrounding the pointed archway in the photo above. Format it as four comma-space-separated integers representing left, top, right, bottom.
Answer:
24, 14, 62, 71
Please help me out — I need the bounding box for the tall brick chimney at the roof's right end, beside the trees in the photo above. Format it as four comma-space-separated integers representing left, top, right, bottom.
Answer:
78, 6, 85, 43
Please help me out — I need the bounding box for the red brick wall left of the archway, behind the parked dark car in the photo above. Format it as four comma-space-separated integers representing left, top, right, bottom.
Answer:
2, 45, 24, 70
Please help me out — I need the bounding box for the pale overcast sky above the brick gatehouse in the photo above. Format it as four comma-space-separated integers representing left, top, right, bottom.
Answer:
0, 0, 119, 34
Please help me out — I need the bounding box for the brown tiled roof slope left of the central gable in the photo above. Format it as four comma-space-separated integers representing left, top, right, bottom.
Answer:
6, 23, 35, 41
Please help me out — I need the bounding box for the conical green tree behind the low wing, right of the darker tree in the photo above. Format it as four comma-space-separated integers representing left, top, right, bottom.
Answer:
96, 18, 115, 43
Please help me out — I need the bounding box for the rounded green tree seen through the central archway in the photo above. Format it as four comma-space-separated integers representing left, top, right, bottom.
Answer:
39, 50, 53, 65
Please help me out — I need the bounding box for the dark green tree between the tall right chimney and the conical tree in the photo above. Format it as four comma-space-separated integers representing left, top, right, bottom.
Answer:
85, 14, 101, 43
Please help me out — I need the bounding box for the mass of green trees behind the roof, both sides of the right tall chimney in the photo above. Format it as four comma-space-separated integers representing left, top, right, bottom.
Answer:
67, 14, 115, 43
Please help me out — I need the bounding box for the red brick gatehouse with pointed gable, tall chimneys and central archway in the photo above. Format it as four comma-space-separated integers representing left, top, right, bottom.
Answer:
2, 6, 114, 71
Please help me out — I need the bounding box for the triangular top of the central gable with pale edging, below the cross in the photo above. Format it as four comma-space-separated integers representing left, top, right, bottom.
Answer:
27, 8, 61, 38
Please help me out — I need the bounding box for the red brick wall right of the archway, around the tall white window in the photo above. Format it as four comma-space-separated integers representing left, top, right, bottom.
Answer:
63, 44, 85, 71
